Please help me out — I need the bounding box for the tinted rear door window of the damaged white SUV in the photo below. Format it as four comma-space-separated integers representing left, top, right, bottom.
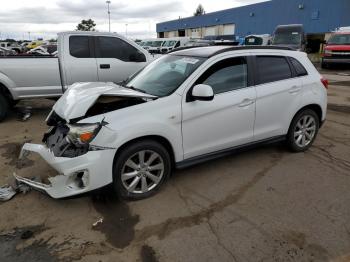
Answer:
256, 56, 292, 84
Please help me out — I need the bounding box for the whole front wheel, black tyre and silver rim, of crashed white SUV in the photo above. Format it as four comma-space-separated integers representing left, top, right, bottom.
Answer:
113, 140, 171, 200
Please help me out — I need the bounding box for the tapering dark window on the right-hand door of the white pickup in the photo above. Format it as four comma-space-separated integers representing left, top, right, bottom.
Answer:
96, 36, 146, 62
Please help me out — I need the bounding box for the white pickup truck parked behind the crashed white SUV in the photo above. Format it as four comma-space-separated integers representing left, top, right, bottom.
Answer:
0, 32, 154, 121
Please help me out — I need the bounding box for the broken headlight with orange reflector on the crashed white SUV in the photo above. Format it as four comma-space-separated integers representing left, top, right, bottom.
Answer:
67, 123, 101, 145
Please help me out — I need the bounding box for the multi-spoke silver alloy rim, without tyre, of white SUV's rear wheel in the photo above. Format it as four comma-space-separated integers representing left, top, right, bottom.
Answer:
294, 115, 316, 147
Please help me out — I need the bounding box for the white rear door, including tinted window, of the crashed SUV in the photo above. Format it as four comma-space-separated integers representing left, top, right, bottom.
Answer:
254, 55, 303, 141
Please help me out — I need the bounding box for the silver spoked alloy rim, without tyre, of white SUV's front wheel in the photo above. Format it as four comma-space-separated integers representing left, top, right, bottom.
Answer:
121, 150, 164, 194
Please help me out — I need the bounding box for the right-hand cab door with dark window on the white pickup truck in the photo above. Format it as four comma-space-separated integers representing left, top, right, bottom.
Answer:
94, 36, 147, 83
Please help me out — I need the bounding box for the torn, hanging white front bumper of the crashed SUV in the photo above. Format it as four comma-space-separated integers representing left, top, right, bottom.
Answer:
14, 143, 116, 198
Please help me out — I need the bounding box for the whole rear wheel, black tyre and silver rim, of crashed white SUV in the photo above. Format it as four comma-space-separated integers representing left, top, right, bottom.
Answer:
287, 109, 320, 152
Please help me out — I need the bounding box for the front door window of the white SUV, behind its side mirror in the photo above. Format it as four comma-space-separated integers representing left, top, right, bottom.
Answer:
196, 57, 248, 94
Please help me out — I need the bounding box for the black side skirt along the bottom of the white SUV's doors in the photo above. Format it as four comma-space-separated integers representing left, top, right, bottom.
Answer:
175, 135, 286, 169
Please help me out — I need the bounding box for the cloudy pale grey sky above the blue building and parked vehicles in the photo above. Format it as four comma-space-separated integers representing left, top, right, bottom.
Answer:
0, 0, 265, 40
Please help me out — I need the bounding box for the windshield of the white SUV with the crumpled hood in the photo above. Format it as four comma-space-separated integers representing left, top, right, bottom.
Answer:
126, 55, 205, 97
